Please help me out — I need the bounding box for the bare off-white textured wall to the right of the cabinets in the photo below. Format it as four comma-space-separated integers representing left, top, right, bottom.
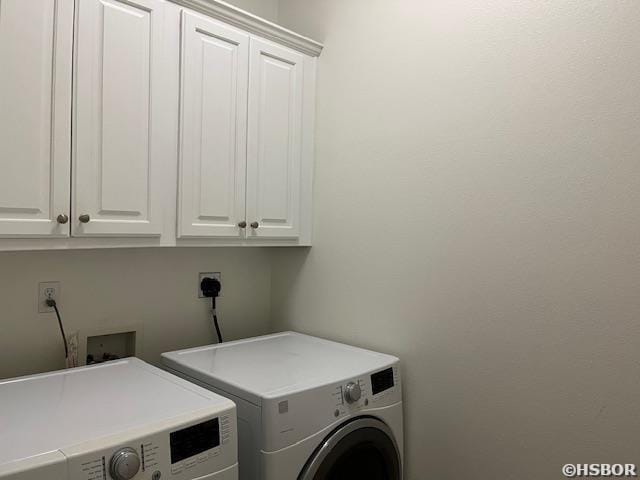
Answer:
273, 0, 640, 480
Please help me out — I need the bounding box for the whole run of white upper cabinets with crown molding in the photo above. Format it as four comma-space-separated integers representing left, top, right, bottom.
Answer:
0, 0, 322, 250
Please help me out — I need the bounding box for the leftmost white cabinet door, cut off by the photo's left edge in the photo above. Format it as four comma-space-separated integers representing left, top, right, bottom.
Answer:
0, 0, 73, 237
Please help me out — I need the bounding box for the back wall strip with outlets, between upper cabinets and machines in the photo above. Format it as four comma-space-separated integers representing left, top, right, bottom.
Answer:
0, 248, 271, 378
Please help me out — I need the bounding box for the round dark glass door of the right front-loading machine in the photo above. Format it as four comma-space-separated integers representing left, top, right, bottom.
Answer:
298, 417, 402, 480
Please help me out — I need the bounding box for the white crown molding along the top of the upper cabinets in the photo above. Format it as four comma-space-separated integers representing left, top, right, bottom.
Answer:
170, 0, 323, 57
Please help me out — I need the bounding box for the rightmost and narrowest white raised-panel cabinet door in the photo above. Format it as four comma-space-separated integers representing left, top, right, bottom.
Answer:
247, 38, 303, 238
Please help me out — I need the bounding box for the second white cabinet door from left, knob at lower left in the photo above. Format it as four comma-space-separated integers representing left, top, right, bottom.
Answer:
72, 0, 167, 236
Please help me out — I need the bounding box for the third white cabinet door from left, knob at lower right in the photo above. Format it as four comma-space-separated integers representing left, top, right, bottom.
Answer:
178, 12, 249, 237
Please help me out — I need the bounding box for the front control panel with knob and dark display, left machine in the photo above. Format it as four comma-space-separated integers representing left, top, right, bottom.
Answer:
62, 408, 237, 480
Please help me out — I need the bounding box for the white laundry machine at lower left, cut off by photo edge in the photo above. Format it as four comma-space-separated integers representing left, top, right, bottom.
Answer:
0, 359, 238, 480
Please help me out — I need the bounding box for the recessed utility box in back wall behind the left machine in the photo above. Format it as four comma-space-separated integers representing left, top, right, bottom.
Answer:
78, 324, 142, 365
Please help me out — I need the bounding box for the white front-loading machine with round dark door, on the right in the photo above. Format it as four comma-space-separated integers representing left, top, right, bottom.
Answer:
162, 332, 403, 480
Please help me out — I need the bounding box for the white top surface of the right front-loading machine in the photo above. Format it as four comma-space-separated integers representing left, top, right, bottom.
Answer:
162, 332, 398, 404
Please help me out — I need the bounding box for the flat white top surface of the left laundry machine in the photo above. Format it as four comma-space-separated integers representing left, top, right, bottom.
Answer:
0, 358, 231, 465
